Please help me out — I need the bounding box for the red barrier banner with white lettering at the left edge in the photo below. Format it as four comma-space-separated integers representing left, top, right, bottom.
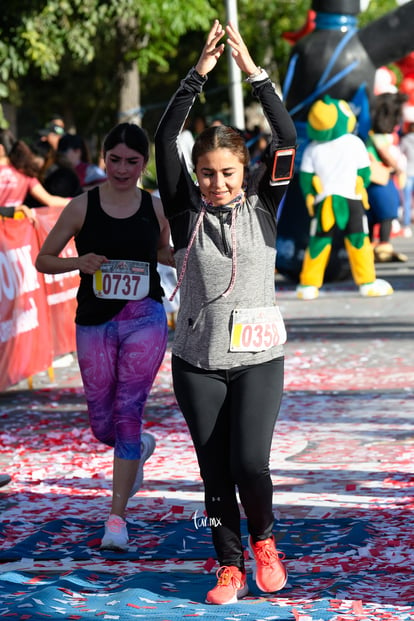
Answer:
0, 208, 79, 390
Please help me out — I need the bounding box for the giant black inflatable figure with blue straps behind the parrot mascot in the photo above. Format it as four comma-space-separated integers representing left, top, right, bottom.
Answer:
276, 0, 414, 280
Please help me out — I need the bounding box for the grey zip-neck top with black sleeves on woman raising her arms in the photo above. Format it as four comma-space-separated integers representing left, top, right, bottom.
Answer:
155, 69, 296, 370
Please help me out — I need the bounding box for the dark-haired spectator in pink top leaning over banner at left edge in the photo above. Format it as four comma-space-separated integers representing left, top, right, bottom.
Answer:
0, 129, 68, 218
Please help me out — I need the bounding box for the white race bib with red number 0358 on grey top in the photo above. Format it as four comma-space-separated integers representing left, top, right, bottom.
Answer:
230, 306, 286, 352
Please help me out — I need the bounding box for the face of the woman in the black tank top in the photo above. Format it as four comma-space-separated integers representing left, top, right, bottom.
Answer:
105, 143, 145, 190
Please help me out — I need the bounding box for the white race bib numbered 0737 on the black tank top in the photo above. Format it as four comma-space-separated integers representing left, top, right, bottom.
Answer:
93, 259, 149, 300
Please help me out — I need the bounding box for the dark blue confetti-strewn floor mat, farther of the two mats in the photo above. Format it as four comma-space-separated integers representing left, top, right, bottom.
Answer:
0, 518, 378, 562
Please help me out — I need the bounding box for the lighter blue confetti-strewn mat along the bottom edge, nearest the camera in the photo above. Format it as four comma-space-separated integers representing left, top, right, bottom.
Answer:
0, 570, 414, 621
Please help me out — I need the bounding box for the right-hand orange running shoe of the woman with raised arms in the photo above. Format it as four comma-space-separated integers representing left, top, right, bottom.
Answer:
249, 536, 287, 593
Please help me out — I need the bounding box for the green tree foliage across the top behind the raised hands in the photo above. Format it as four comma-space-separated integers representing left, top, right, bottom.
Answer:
0, 0, 408, 146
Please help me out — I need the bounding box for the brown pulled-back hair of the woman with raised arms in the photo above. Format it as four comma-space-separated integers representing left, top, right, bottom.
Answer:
192, 125, 250, 168
